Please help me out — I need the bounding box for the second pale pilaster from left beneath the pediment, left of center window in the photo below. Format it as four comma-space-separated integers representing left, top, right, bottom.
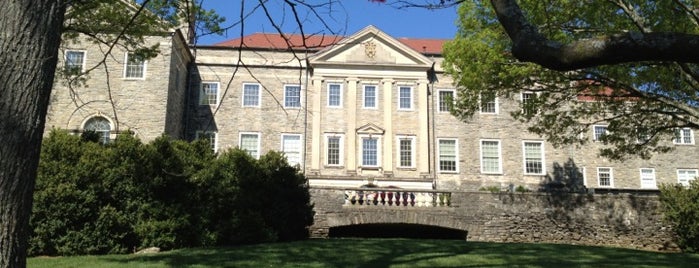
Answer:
345, 78, 358, 175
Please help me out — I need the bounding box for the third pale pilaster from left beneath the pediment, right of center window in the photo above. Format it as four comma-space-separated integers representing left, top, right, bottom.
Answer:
381, 79, 393, 177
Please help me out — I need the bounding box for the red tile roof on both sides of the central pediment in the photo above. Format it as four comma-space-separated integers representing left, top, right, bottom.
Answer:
214, 33, 448, 54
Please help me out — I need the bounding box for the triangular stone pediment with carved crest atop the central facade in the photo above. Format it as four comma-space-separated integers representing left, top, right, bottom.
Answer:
310, 25, 432, 68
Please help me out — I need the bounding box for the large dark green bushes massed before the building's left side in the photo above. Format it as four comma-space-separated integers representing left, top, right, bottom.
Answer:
30, 130, 313, 255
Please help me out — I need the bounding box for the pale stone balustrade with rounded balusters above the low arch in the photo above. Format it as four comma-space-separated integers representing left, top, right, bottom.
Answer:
344, 188, 451, 207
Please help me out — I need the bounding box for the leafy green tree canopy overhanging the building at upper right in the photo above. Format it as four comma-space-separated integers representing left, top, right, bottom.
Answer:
443, 0, 699, 160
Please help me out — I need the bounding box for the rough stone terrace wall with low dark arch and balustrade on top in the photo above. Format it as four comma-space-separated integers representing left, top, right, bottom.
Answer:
310, 187, 677, 251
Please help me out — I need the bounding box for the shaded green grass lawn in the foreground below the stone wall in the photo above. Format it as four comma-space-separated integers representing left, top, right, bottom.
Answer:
28, 239, 699, 267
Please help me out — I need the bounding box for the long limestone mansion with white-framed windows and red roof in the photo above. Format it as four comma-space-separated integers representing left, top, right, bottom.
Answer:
46, 26, 699, 190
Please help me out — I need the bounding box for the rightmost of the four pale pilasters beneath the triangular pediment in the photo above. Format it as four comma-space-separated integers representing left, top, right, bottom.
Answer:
415, 80, 434, 175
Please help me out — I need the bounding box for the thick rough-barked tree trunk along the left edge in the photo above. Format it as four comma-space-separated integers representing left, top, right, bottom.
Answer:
0, 0, 66, 268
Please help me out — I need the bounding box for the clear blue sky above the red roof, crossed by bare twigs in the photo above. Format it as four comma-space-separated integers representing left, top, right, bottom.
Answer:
198, 0, 457, 45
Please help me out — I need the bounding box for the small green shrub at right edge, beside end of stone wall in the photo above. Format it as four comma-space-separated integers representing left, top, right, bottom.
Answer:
660, 180, 699, 252
